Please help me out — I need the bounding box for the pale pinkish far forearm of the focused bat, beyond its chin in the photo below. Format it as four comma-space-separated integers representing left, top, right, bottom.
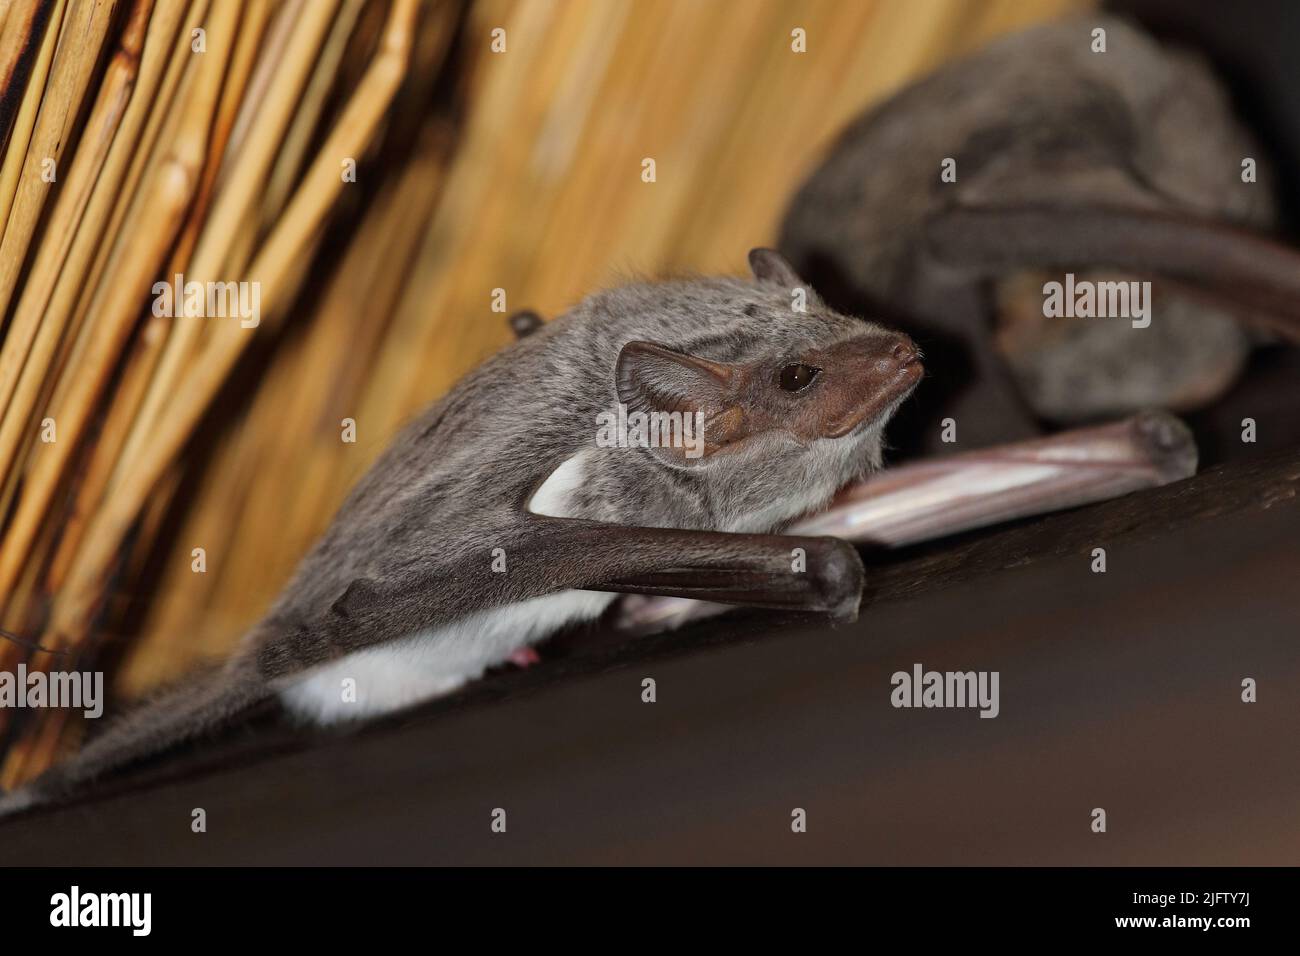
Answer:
615, 411, 1197, 632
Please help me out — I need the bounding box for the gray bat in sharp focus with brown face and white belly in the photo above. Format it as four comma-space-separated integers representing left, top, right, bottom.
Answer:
0, 250, 922, 810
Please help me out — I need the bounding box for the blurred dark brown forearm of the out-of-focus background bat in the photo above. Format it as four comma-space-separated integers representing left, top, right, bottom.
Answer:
926, 206, 1300, 342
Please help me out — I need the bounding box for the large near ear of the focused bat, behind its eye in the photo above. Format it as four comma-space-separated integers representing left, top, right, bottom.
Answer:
614, 342, 745, 459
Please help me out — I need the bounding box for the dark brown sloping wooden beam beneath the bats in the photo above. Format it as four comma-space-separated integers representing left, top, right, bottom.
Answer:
0, 451, 1300, 865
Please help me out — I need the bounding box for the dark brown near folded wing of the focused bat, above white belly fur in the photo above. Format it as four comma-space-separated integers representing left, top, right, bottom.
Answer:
254, 514, 865, 682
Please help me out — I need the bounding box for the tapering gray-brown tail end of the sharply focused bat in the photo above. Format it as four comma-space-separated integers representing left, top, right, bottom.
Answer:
0, 659, 270, 818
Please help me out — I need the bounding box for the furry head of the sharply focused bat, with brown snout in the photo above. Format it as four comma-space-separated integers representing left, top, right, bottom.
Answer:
598, 250, 922, 531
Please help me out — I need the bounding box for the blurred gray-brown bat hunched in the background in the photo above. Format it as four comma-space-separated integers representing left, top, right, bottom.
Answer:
779, 14, 1300, 450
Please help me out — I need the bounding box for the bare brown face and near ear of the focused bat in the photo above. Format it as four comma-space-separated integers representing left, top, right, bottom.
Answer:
618, 330, 923, 458
